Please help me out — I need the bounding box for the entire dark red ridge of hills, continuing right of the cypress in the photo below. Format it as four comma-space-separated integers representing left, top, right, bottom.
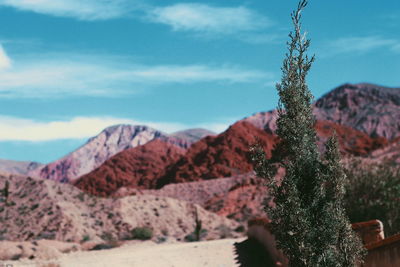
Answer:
74, 121, 387, 196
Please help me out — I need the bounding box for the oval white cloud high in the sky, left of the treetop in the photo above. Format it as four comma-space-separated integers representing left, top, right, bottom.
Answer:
149, 3, 271, 34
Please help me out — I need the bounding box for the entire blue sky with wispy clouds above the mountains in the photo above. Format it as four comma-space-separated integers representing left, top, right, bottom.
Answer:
0, 0, 400, 162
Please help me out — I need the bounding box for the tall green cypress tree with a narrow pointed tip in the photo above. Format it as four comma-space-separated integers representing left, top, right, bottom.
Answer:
253, 0, 363, 267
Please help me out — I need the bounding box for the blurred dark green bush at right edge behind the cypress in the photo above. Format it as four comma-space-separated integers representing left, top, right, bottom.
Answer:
344, 160, 400, 236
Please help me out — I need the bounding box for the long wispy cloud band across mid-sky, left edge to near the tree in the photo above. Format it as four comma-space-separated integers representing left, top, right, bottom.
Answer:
0, 50, 272, 98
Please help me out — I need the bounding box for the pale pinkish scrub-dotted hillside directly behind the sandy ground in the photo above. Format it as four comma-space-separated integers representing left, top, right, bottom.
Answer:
0, 175, 239, 245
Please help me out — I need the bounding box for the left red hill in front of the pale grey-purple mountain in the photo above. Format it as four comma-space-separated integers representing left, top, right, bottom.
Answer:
74, 139, 185, 196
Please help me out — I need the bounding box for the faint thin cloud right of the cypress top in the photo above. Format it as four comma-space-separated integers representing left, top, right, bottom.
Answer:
321, 36, 400, 57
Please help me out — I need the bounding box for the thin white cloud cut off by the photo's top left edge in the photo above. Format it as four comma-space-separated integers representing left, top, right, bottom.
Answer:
0, 0, 138, 20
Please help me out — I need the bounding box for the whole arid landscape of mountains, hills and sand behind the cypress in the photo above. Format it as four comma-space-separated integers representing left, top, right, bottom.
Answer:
0, 84, 400, 267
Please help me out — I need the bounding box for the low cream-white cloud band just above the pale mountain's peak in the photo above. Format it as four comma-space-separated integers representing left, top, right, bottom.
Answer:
0, 115, 230, 142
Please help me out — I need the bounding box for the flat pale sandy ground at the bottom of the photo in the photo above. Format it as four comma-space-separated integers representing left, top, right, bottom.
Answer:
9, 238, 245, 267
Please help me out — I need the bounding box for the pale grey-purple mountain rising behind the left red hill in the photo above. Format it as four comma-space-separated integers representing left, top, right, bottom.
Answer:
28, 125, 188, 182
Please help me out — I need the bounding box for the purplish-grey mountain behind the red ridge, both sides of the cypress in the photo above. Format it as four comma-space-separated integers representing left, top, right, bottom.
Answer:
244, 83, 400, 140
